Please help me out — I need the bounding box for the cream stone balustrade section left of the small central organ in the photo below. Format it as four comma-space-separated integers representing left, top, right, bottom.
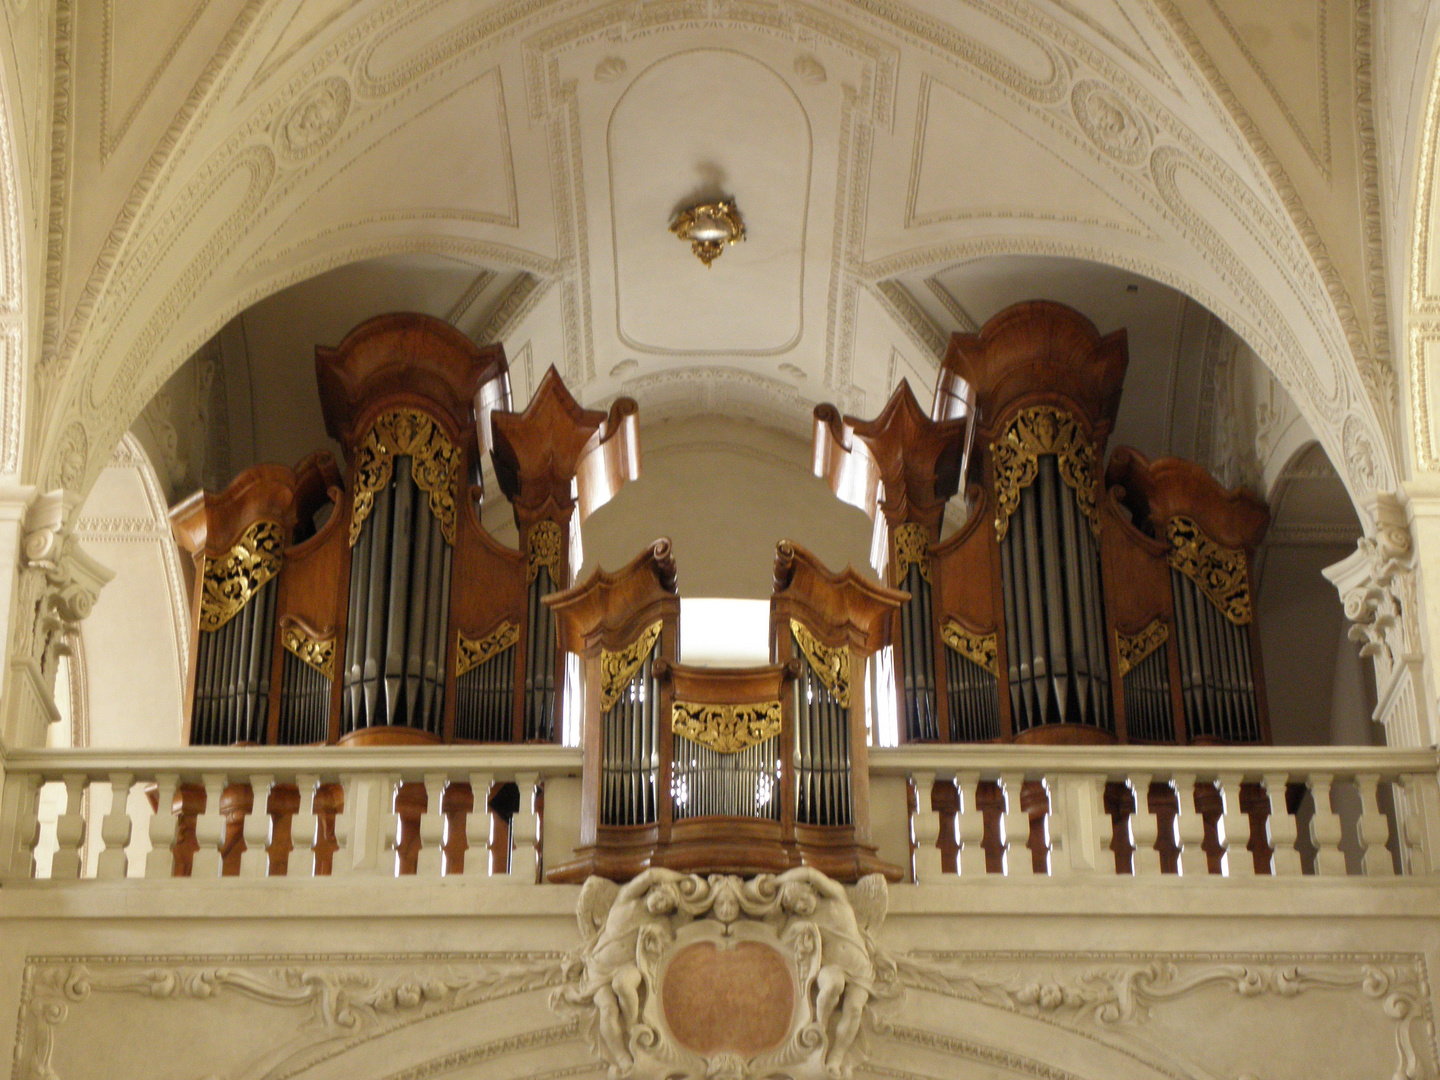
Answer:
0, 746, 580, 884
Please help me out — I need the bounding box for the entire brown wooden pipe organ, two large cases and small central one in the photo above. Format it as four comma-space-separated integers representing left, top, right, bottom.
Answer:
171, 301, 1269, 883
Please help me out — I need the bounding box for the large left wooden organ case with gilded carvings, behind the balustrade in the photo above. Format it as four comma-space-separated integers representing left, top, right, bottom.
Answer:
171, 314, 638, 744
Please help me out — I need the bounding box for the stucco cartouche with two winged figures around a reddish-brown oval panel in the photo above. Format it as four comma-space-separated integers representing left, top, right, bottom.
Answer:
550, 867, 900, 1080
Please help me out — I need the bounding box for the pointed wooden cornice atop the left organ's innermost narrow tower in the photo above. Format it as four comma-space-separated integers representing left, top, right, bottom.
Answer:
490, 367, 639, 527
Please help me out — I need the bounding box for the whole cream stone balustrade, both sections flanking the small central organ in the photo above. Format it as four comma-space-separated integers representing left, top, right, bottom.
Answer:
0, 744, 1440, 884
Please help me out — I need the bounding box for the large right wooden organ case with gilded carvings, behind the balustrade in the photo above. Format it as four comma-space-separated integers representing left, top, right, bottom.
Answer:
815, 301, 1269, 743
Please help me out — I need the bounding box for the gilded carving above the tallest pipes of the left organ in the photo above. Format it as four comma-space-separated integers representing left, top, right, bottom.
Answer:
350, 409, 461, 547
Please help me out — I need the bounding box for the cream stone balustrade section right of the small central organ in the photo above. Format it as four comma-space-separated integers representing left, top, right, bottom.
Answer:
870, 746, 1440, 883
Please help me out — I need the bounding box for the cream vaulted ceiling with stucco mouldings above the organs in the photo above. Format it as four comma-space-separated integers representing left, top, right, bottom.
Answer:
6, 0, 1416, 529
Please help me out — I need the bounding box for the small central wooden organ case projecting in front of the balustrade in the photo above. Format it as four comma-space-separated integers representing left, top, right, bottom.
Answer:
547, 540, 906, 881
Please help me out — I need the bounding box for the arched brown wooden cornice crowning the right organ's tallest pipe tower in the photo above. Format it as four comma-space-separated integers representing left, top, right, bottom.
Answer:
943, 300, 1129, 448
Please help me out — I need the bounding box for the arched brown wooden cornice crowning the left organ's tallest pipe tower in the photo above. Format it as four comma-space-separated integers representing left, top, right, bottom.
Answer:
315, 312, 507, 461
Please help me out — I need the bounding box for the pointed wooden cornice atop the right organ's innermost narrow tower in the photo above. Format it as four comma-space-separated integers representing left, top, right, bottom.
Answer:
815, 379, 968, 537
